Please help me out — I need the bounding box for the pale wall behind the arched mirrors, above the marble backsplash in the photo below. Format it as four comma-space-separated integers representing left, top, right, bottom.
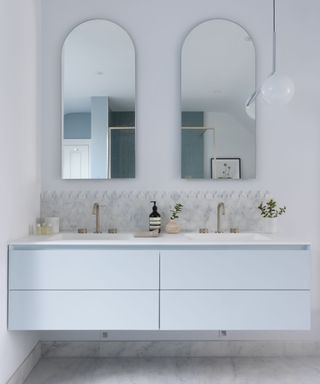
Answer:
42, 0, 320, 338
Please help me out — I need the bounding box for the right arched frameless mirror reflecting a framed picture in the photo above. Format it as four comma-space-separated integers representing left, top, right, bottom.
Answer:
181, 19, 256, 179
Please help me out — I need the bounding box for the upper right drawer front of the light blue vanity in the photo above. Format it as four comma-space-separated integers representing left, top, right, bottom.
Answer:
160, 250, 311, 289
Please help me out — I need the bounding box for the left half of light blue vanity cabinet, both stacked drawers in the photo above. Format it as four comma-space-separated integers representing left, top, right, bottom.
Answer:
9, 247, 159, 330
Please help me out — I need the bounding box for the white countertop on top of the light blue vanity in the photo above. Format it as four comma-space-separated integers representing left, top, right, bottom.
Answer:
9, 232, 311, 247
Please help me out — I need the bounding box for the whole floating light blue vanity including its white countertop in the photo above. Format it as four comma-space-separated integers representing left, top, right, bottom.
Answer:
8, 233, 311, 330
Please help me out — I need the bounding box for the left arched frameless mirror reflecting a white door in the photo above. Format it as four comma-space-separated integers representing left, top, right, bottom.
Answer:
61, 20, 135, 179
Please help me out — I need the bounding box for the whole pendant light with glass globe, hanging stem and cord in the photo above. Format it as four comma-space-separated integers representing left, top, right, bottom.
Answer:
246, 0, 295, 117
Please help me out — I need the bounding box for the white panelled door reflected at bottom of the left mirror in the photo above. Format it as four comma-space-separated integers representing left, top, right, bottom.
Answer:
63, 144, 89, 179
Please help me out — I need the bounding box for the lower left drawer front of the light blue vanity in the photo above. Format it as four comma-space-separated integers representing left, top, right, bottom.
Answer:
8, 291, 159, 330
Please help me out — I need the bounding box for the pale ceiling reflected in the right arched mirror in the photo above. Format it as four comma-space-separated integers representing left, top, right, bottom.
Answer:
181, 19, 255, 111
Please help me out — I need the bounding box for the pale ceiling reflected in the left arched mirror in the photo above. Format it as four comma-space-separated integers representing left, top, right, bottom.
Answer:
62, 20, 135, 114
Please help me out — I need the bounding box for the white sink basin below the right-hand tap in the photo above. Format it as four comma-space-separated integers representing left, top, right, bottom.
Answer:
185, 232, 270, 242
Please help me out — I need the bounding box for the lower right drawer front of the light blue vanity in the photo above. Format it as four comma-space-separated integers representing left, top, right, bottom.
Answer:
160, 291, 310, 330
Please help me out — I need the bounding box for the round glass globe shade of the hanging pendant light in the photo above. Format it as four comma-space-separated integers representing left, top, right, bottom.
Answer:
261, 73, 295, 105
